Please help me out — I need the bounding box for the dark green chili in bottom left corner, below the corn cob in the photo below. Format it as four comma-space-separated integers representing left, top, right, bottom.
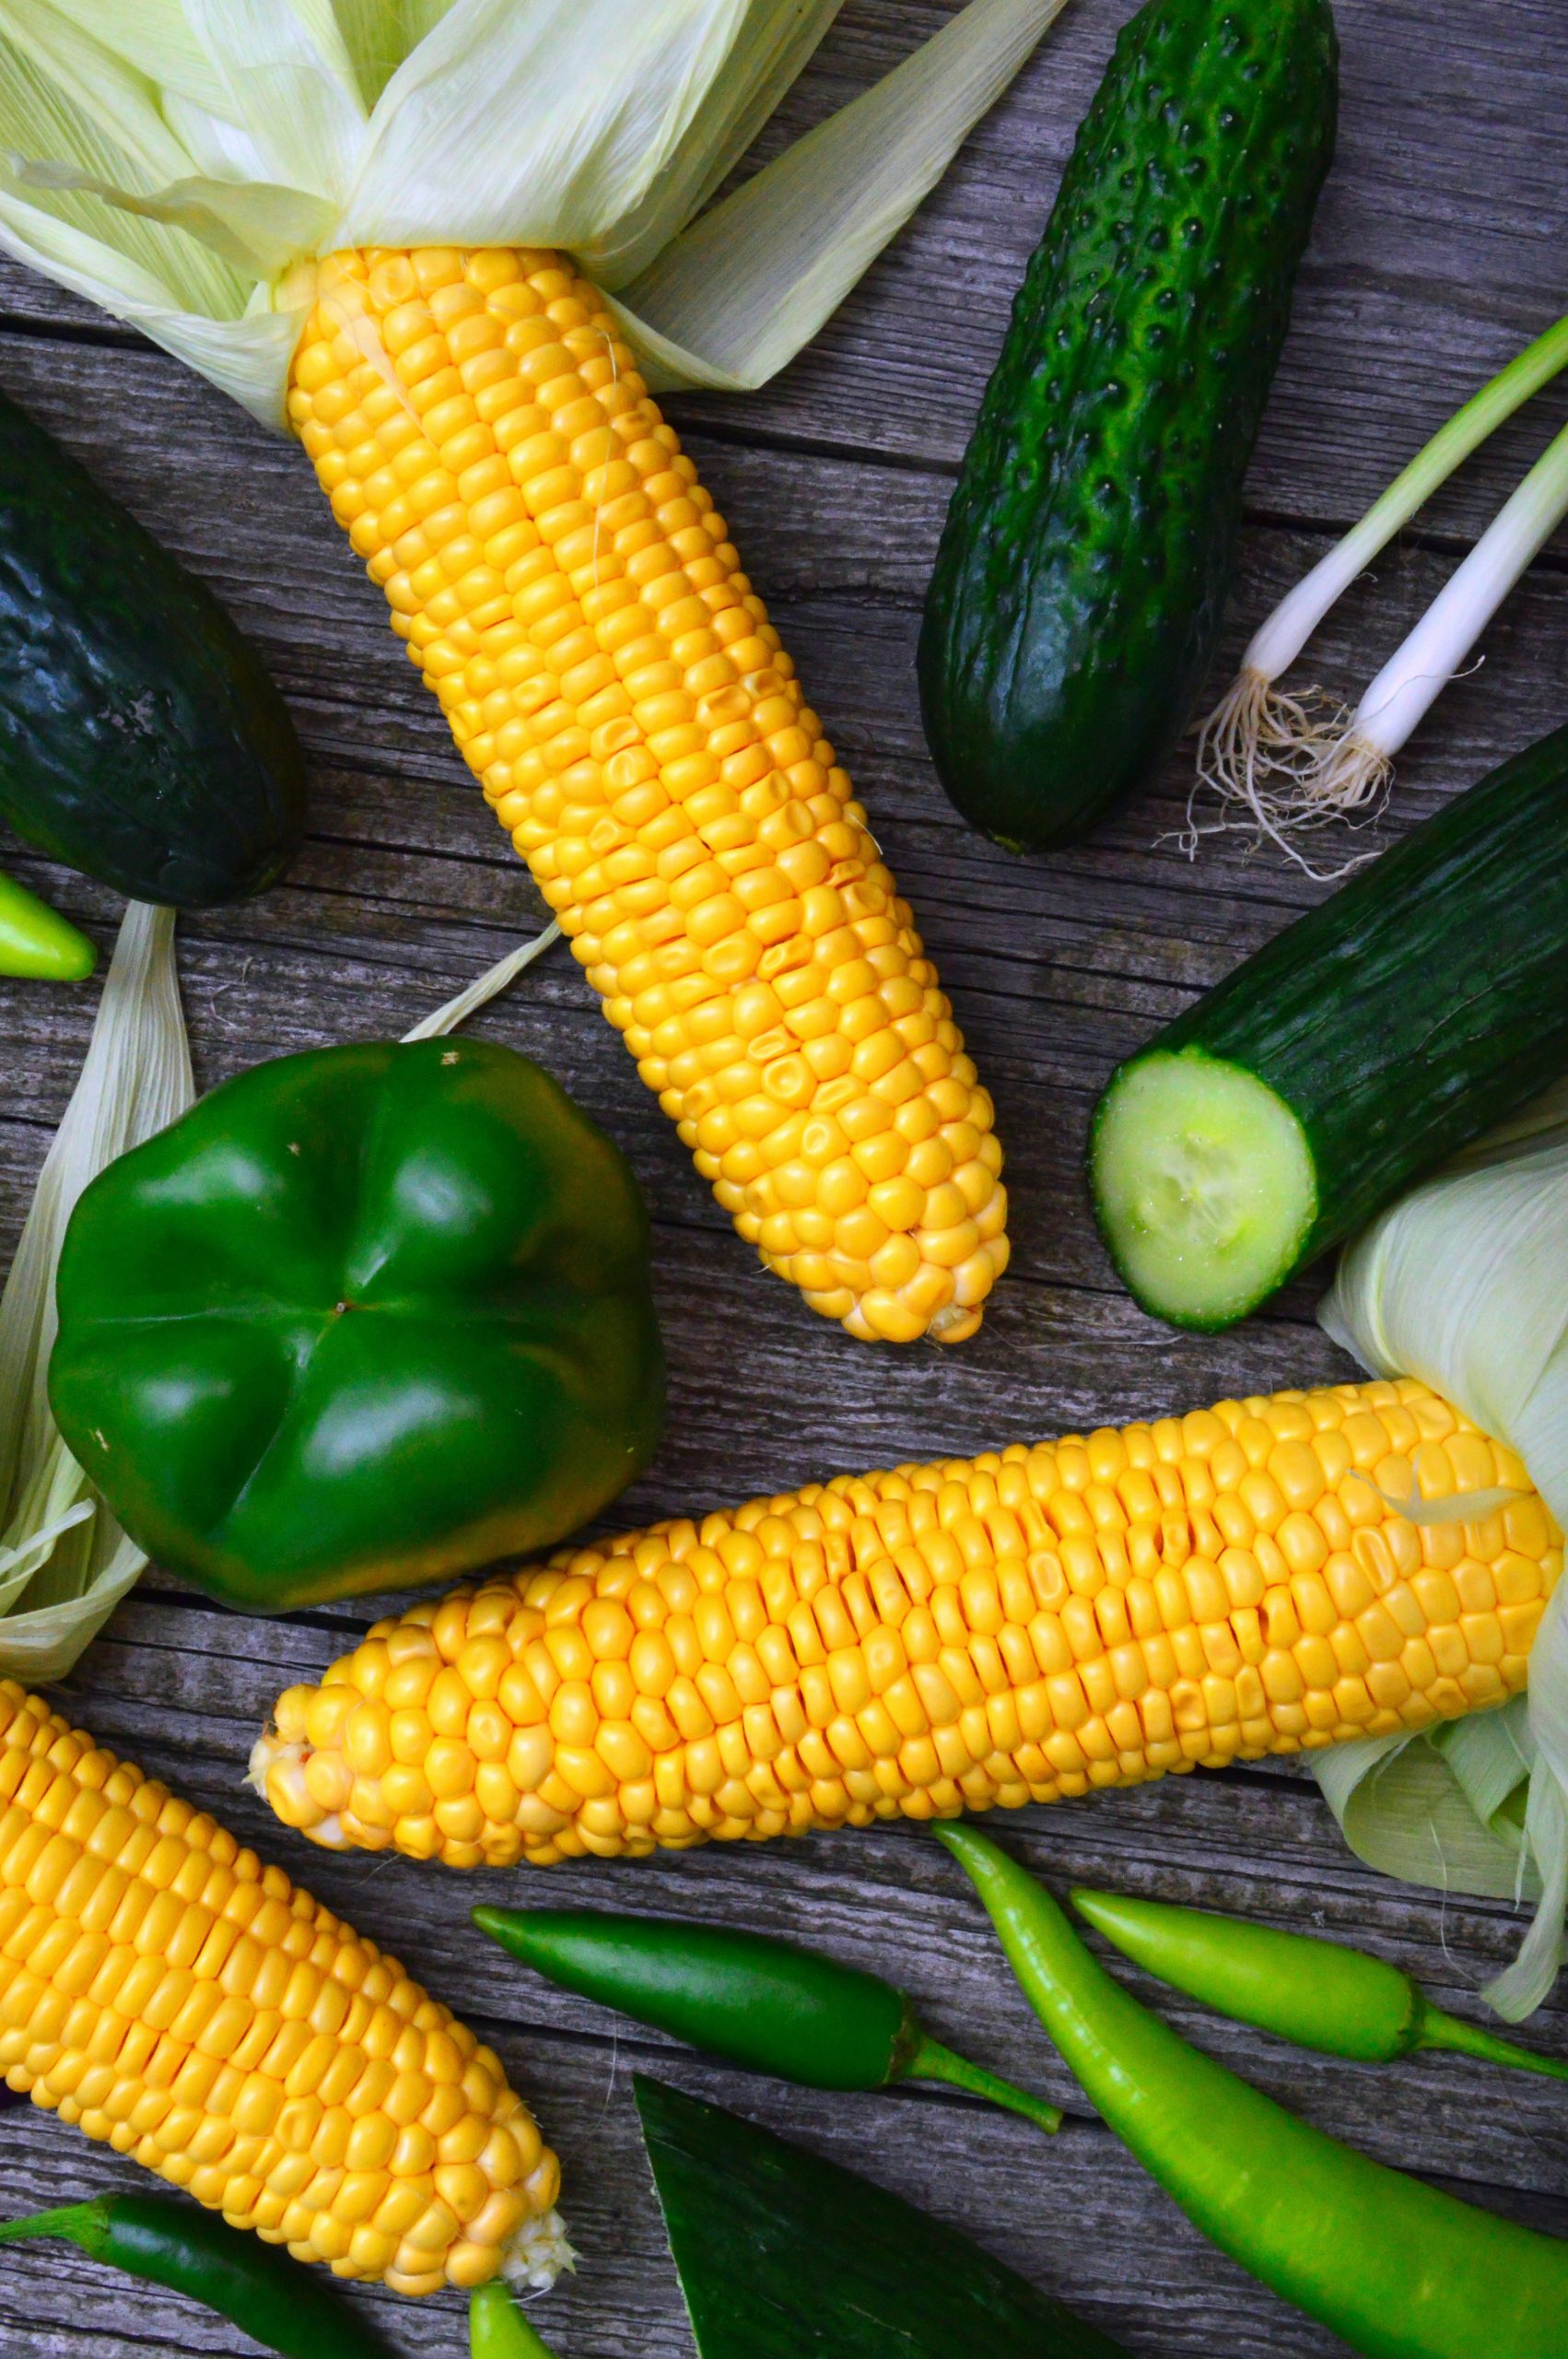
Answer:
0, 2196, 392, 2359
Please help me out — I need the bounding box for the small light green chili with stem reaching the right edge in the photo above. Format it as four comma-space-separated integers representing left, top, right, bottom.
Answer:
1071, 1892, 1568, 2081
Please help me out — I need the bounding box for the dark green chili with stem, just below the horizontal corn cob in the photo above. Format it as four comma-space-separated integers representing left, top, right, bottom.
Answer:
474, 1908, 1061, 2130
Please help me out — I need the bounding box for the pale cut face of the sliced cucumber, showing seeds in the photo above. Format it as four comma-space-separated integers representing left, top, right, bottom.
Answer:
1089, 1048, 1318, 1328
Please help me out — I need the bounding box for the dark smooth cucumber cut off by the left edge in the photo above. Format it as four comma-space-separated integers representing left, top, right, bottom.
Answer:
0, 396, 304, 909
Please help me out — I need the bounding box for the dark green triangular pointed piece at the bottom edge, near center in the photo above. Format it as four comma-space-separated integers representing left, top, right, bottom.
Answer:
634, 2073, 1127, 2359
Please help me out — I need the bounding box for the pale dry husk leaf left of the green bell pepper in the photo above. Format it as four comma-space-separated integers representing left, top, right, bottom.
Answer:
0, 901, 195, 1684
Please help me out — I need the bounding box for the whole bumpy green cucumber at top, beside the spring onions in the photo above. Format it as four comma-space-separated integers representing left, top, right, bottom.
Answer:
919, 0, 1340, 851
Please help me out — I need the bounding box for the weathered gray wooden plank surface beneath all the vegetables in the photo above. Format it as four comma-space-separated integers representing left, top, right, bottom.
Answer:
0, 0, 1568, 2359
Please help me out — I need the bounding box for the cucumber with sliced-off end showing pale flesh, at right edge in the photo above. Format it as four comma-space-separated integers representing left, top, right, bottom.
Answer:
1089, 729, 1568, 1328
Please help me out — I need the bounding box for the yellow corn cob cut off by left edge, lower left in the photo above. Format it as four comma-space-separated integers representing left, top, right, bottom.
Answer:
0, 1680, 566, 2293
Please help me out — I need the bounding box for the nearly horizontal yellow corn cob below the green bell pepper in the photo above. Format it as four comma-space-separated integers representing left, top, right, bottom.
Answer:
252, 1380, 1563, 1869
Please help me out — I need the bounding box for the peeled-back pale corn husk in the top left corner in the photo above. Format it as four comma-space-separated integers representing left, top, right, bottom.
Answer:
0, 0, 1063, 425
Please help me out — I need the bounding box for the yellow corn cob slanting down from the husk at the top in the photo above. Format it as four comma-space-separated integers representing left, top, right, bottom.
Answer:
290, 248, 1007, 1343
